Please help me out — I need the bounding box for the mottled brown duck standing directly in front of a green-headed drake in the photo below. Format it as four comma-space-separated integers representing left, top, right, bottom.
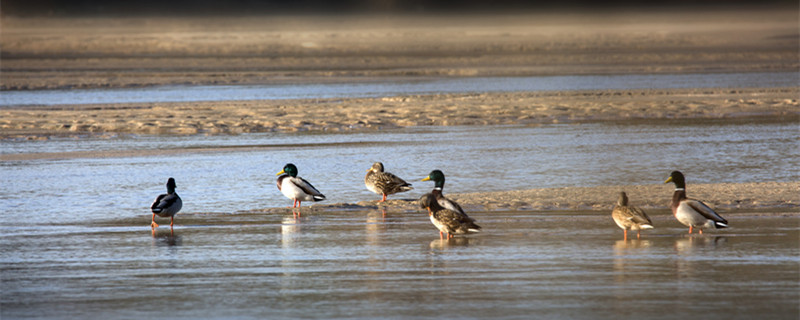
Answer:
419, 193, 481, 240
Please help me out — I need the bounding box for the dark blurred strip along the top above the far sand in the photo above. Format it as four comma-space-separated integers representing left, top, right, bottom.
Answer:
0, 0, 798, 16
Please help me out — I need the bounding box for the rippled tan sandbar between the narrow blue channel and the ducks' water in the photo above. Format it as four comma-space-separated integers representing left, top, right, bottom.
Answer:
0, 87, 800, 139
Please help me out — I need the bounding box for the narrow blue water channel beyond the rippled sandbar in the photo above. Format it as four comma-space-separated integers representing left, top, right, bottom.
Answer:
0, 72, 800, 107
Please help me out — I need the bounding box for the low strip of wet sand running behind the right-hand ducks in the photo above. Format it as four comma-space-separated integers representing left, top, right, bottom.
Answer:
270, 182, 800, 215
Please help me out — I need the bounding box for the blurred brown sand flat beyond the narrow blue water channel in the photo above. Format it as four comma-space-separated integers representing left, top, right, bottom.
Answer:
0, 10, 800, 90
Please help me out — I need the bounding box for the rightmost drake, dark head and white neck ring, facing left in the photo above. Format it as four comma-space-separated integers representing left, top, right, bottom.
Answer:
664, 171, 728, 234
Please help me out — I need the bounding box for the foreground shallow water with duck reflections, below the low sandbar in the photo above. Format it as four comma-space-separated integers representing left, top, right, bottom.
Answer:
0, 208, 800, 319
